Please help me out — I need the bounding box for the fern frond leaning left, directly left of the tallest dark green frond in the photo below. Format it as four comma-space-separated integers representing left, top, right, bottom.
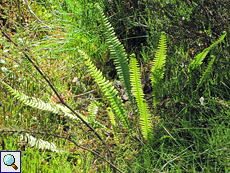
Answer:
78, 50, 132, 134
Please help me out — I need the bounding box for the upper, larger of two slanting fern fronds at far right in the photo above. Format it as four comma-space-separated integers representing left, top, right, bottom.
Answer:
188, 31, 227, 72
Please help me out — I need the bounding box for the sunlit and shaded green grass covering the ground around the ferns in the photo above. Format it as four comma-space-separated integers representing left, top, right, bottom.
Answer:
0, 0, 230, 172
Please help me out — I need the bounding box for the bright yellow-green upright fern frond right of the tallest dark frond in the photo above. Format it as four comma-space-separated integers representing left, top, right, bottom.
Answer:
130, 54, 151, 139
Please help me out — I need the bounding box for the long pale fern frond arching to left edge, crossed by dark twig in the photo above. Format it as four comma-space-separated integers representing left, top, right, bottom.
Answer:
0, 80, 106, 129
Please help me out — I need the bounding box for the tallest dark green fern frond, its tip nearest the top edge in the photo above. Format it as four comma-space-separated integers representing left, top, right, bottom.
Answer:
97, 5, 134, 105
